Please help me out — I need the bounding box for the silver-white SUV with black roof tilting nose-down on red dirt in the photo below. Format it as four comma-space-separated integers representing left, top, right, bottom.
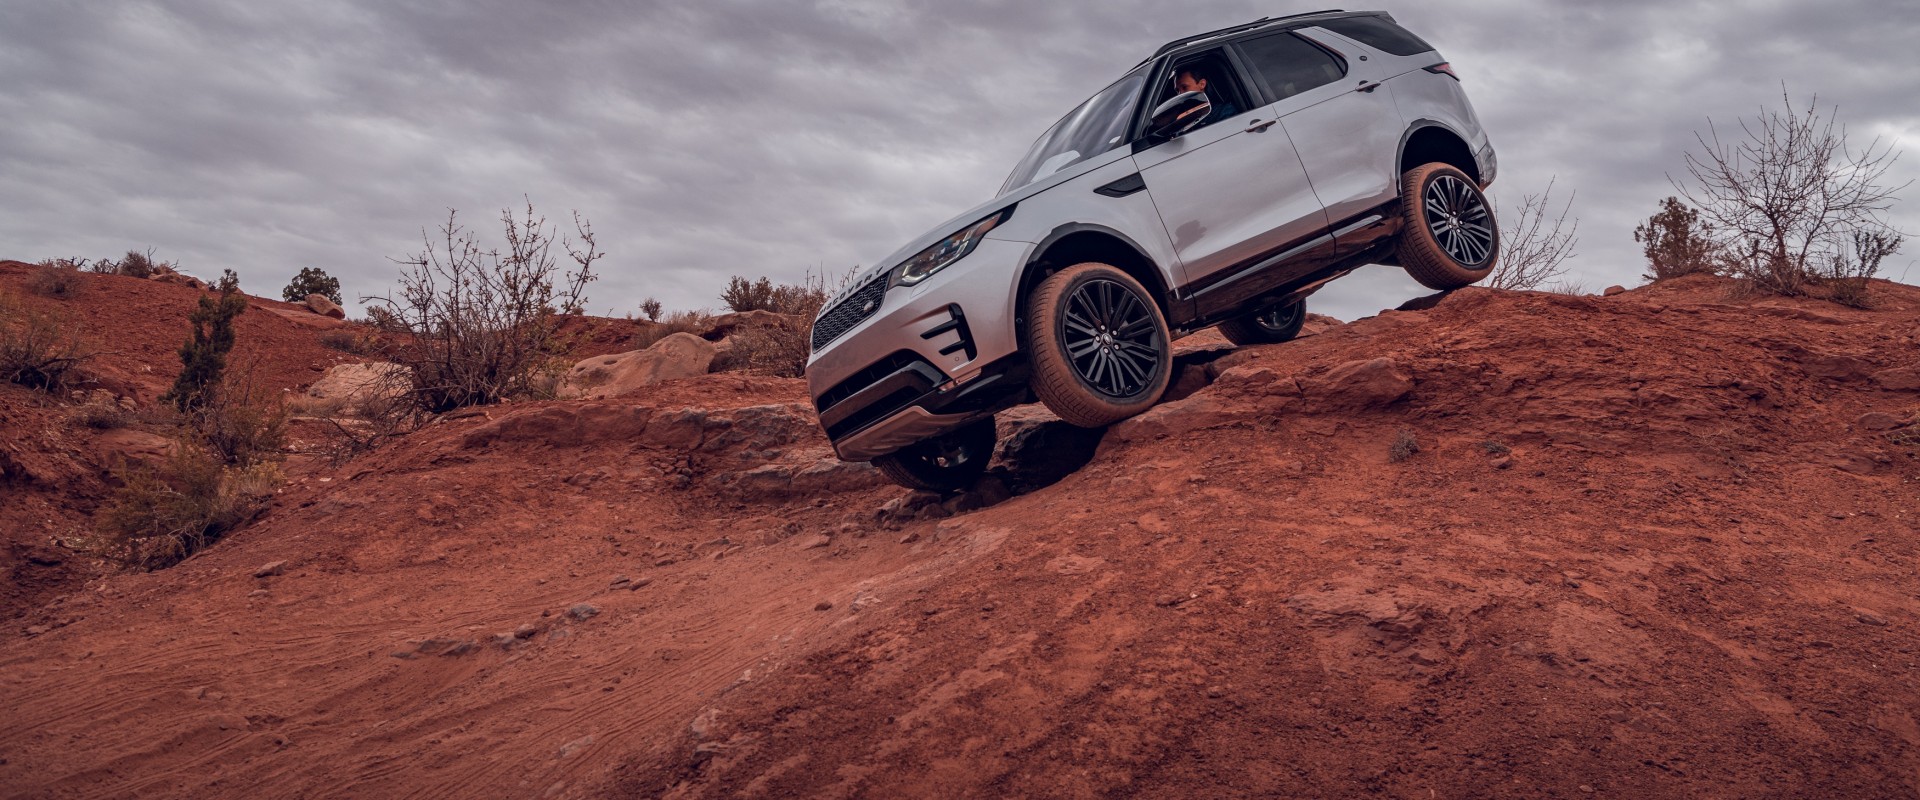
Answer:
806, 12, 1500, 491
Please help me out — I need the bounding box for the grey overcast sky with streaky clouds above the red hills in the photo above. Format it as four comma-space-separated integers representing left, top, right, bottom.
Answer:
0, 0, 1920, 318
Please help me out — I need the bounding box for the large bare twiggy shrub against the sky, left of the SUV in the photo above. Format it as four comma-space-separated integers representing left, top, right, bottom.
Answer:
361, 201, 603, 412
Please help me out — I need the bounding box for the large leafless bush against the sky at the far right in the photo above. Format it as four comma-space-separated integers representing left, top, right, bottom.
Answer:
1674, 90, 1905, 303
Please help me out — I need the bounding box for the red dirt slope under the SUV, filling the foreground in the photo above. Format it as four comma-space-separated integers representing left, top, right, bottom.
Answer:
0, 262, 1920, 798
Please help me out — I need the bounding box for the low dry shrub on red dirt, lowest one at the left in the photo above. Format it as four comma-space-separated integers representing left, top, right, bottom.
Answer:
90, 441, 282, 570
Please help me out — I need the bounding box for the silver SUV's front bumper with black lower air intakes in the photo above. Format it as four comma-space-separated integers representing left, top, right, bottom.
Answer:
806, 238, 1031, 460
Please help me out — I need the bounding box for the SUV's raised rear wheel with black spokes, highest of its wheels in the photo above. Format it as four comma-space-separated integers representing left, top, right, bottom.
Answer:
1396, 163, 1500, 292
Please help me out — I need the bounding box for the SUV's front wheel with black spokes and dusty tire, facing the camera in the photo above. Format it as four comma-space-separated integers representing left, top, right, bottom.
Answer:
1027, 263, 1173, 428
